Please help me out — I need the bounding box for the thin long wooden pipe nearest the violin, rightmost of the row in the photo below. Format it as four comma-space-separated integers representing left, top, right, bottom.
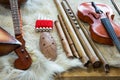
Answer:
62, 2, 110, 73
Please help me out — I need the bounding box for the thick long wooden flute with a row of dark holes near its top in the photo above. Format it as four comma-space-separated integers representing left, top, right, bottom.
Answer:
62, 0, 101, 68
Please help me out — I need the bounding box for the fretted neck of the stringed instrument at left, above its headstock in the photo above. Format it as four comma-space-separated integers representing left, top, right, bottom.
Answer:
9, 0, 21, 35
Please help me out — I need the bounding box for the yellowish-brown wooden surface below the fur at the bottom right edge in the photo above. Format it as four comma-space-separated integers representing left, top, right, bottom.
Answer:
55, 68, 120, 80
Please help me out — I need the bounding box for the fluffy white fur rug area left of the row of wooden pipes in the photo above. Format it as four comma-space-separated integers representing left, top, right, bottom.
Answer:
0, 0, 83, 80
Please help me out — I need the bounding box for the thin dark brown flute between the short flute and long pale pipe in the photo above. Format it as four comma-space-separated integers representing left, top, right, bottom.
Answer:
58, 15, 80, 58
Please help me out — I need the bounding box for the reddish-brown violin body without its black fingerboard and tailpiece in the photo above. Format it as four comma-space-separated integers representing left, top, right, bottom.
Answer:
77, 3, 120, 45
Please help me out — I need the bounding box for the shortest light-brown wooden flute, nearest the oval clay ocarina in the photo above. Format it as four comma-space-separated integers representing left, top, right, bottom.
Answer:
55, 21, 73, 58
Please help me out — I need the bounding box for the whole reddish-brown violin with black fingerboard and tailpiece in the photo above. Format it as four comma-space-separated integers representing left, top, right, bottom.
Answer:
77, 2, 120, 51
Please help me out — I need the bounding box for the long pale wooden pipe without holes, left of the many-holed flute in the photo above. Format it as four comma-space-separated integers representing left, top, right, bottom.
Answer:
54, 0, 89, 66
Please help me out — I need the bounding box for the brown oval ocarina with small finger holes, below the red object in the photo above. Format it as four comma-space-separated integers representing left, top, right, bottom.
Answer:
40, 32, 57, 61
